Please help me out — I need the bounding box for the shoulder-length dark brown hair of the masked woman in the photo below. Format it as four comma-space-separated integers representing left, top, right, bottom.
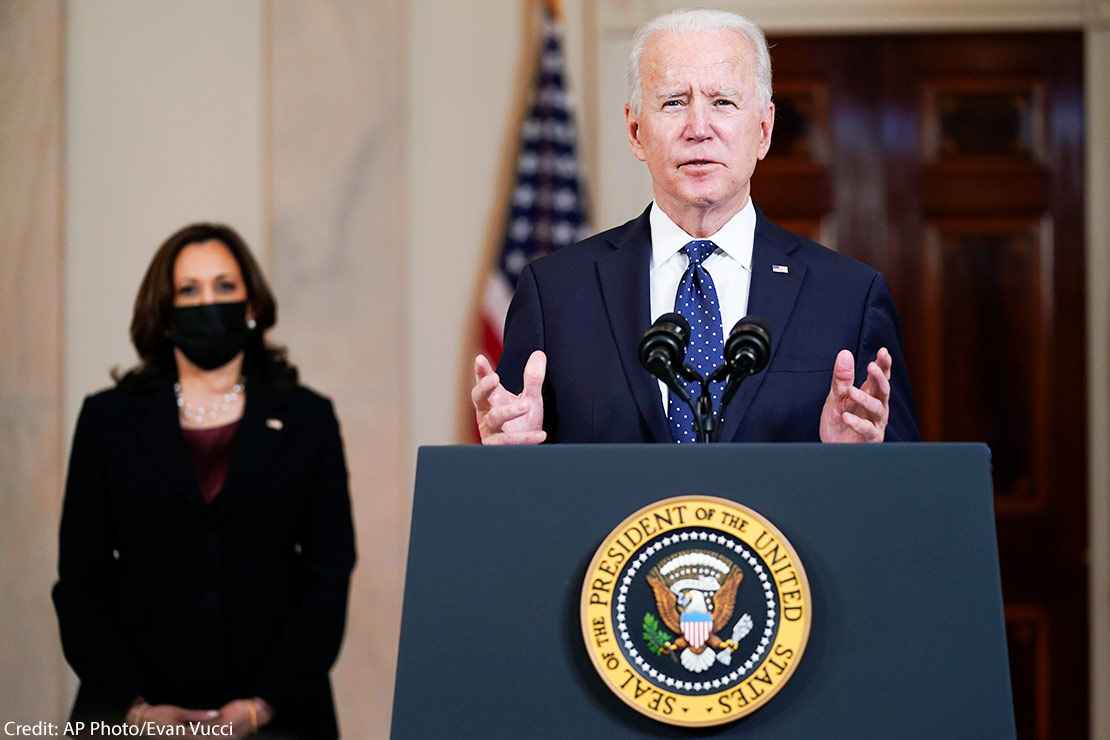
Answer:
112, 223, 297, 388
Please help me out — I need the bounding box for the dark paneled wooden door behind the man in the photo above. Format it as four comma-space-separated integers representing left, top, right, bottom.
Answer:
753, 33, 1089, 740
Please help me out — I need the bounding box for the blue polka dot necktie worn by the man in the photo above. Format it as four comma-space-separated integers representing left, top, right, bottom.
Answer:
667, 239, 725, 444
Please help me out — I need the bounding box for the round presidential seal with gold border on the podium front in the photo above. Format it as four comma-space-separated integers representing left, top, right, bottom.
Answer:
582, 496, 811, 727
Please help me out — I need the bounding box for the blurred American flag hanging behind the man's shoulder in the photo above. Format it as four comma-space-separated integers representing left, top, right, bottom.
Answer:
482, 7, 588, 366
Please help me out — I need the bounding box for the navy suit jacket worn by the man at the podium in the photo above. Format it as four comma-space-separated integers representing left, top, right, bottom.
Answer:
497, 209, 918, 443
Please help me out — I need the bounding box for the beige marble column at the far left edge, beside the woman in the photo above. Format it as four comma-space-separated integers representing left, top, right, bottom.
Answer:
0, 0, 67, 731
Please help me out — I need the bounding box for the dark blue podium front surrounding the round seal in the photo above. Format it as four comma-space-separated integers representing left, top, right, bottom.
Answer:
392, 444, 1015, 740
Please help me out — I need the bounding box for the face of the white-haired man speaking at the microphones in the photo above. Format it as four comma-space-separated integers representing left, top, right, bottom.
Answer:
625, 30, 775, 217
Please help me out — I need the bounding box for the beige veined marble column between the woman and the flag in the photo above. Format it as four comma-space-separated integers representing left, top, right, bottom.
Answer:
266, 0, 412, 738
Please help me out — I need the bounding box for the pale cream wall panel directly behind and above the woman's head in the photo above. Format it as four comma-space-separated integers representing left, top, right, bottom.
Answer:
64, 0, 266, 436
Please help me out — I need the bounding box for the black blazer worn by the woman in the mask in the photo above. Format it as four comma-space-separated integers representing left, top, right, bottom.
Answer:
53, 383, 355, 738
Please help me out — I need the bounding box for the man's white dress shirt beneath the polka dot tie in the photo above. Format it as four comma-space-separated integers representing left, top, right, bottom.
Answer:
648, 197, 756, 412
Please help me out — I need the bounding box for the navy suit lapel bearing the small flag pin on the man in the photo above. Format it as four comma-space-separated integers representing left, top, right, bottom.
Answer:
720, 207, 806, 442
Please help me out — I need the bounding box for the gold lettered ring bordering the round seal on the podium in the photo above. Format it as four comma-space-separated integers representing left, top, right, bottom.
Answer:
579, 494, 813, 727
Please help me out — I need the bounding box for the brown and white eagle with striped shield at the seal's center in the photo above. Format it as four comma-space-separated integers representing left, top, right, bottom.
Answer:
647, 550, 746, 673
